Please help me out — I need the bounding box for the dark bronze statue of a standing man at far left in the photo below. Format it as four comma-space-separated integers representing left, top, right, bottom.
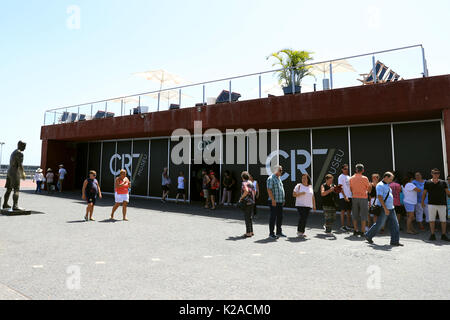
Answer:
3, 141, 27, 211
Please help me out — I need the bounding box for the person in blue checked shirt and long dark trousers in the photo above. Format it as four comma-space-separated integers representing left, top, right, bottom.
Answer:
267, 165, 286, 239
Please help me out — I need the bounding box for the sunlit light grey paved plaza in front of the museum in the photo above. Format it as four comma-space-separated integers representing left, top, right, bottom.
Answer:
0, 189, 450, 300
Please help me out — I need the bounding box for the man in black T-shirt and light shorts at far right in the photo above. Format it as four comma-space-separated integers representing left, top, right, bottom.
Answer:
421, 169, 450, 241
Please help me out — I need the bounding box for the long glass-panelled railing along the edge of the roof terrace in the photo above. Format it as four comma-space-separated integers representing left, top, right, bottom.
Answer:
44, 44, 428, 126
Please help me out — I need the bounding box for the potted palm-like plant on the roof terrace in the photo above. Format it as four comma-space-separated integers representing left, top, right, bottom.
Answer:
267, 49, 314, 95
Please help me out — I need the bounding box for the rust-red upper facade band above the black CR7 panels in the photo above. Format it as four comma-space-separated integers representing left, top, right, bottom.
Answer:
41, 75, 450, 190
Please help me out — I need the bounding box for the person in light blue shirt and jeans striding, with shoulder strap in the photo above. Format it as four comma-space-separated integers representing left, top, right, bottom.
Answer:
364, 172, 403, 247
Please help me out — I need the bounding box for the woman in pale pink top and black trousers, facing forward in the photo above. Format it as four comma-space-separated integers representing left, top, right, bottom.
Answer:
293, 173, 316, 238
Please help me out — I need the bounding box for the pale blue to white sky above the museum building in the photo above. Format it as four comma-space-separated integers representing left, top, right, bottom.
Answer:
0, 0, 450, 164
